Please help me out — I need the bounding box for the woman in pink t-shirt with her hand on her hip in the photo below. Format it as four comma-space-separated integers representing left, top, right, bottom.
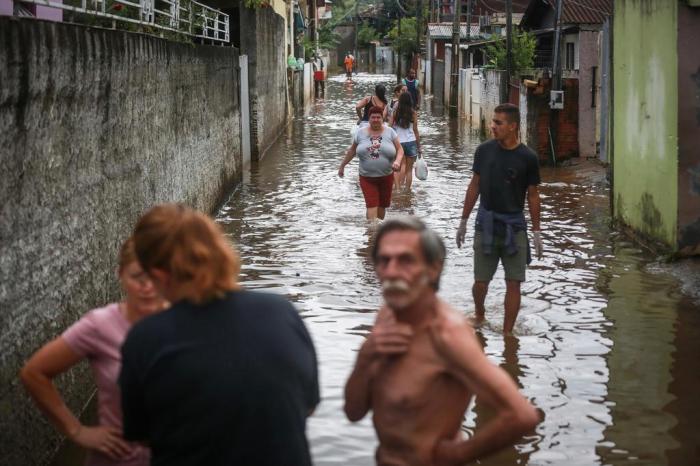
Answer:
20, 238, 167, 466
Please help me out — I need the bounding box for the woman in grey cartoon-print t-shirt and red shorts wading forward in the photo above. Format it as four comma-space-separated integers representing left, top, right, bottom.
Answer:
338, 107, 403, 221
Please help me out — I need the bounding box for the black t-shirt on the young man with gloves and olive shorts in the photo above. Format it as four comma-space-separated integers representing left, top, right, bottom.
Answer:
472, 139, 540, 214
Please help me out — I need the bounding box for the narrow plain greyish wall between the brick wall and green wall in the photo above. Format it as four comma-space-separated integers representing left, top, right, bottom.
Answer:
578, 30, 600, 157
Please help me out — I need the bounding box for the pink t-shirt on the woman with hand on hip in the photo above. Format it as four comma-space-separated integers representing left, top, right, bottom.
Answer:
62, 303, 150, 466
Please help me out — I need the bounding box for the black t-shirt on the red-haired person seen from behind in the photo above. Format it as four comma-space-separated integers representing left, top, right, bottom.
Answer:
119, 291, 319, 466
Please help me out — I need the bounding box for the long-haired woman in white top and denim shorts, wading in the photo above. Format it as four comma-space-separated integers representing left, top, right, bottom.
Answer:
390, 92, 420, 190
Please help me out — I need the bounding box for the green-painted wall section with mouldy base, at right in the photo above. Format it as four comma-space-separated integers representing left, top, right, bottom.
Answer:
613, 0, 678, 247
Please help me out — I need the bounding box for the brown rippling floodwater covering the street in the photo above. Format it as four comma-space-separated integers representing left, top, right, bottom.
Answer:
217, 74, 700, 466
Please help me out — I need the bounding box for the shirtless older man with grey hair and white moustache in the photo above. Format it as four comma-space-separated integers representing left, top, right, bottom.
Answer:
345, 217, 539, 466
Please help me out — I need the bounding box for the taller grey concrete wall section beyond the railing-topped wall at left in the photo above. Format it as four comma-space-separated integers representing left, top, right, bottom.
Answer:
240, 7, 287, 160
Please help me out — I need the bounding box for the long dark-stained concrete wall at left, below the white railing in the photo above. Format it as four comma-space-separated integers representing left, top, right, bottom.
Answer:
0, 17, 241, 466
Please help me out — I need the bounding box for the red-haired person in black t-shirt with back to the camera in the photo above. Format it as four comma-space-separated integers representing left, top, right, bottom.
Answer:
119, 205, 319, 466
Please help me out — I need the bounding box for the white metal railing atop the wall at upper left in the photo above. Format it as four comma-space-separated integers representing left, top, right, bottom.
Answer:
23, 0, 230, 42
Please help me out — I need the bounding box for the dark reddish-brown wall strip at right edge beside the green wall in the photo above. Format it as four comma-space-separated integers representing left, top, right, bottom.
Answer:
678, 4, 700, 254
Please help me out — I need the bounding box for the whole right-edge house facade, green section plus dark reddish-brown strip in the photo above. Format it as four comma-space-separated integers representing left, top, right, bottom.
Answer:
611, 0, 700, 255
